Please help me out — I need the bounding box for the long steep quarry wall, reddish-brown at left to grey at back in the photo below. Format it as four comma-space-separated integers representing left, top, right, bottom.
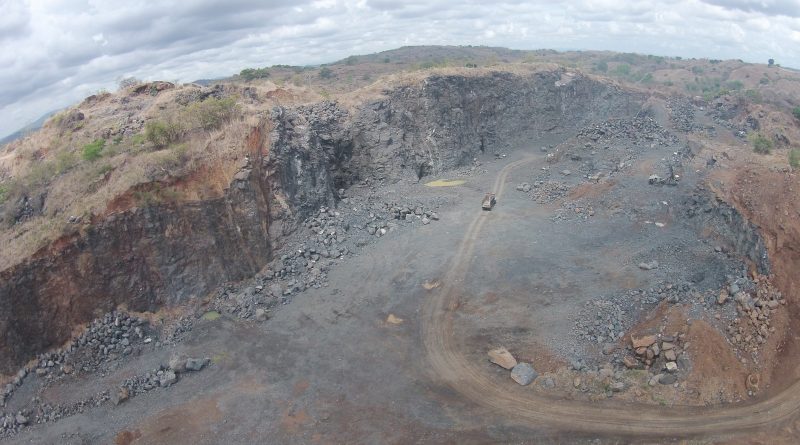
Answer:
0, 70, 643, 372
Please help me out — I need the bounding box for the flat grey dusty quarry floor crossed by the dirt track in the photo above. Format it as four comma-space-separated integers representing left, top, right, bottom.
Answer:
7, 94, 800, 444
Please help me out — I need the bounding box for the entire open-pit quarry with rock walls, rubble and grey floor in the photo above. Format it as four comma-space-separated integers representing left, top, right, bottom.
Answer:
0, 66, 800, 444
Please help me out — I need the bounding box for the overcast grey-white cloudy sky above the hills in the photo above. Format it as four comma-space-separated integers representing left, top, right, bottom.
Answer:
0, 0, 800, 137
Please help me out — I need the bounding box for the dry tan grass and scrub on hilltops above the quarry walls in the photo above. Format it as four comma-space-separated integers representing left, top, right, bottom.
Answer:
0, 48, 800, 268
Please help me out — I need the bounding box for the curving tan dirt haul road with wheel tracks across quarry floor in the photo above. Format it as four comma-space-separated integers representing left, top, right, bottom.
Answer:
422, 156, 800, 437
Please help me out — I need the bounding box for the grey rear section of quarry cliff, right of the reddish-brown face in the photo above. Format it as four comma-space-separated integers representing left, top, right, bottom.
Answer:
268, 70, 644, 216
